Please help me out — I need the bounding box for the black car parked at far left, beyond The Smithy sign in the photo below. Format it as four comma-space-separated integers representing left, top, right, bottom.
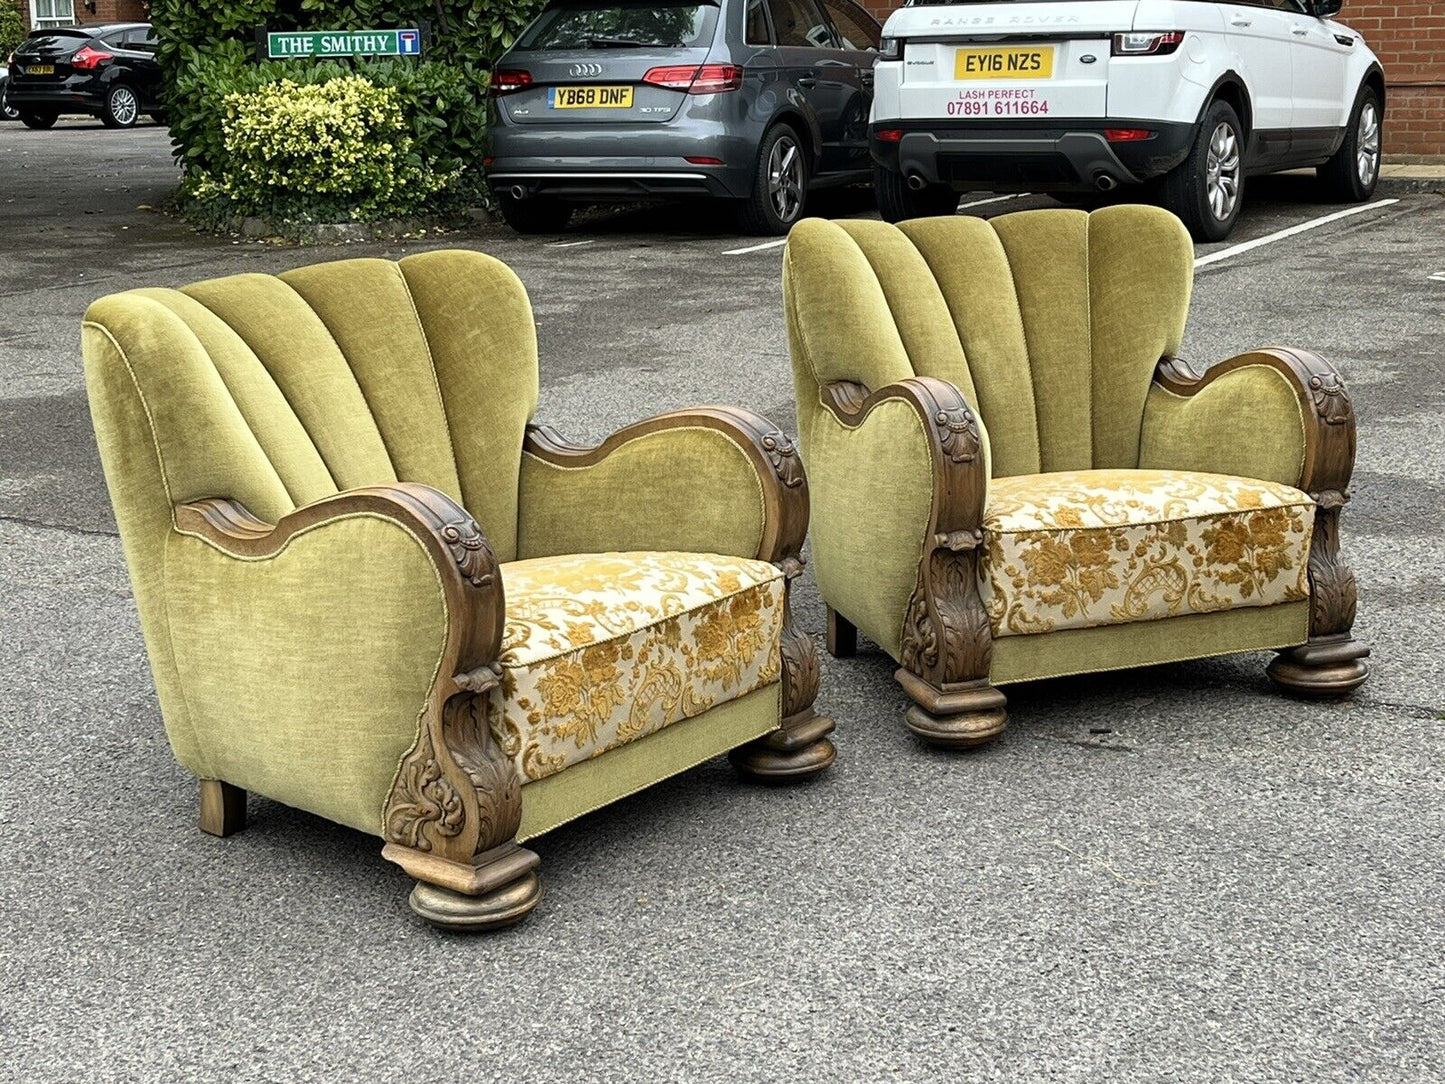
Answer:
6, 23, 160, 129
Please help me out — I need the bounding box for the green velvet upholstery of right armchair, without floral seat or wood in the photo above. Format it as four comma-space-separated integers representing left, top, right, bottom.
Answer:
783, 205, 1305, 681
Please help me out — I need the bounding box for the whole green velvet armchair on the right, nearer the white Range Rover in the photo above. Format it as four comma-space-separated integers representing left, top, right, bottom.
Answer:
783, 207, 1368, 746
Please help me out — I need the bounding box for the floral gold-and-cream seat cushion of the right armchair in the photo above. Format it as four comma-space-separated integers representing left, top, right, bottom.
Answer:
981, 470, 1314, 636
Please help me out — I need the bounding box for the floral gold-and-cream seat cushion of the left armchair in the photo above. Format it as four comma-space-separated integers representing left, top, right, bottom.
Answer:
490, 552, 783, 782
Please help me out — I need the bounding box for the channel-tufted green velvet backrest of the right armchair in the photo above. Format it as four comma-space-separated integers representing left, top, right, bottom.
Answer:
783, 205, 1194, 477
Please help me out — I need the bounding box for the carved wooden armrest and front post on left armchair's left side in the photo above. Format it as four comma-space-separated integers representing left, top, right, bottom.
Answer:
175, 483, 539, 901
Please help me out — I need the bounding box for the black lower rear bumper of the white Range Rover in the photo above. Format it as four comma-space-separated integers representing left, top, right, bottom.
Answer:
868, 119, 1194, 192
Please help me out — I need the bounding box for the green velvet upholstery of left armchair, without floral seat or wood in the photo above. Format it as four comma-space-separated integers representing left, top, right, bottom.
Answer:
82, 251, 780, 834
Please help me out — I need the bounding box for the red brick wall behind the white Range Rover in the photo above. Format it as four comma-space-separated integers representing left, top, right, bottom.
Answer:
863, 0, 1445, 162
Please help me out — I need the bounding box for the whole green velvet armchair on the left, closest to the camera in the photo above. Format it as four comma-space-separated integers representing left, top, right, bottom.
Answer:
84, 251, 834, 928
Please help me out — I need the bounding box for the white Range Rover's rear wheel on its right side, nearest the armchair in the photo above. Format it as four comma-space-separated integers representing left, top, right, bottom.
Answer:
1160, 101, 1244, 241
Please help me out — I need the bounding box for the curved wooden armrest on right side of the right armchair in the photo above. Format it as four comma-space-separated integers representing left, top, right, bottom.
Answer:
1155, 347, 1355, 491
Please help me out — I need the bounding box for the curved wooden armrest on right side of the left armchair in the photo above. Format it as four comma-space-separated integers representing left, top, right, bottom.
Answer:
523, 406, 808, 575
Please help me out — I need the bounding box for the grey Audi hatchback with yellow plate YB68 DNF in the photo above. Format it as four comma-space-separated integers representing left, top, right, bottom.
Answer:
483, 0, 879, 234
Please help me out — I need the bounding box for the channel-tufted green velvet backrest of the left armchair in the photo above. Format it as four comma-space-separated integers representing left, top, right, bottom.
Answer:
84, 251, 538, 560
